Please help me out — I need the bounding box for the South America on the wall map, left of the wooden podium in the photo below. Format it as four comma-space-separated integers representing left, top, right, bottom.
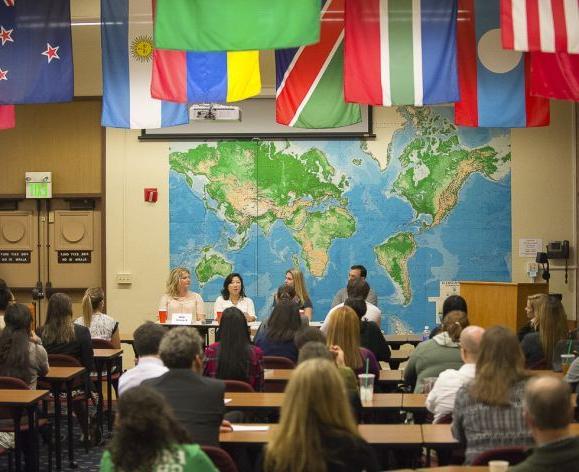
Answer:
374, 232, 416, 305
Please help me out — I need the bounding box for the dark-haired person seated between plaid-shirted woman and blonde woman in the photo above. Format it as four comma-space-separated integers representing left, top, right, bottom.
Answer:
254, 299, 304, 362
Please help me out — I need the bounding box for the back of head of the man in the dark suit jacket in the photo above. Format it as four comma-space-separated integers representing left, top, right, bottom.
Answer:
159, 327, 203, 369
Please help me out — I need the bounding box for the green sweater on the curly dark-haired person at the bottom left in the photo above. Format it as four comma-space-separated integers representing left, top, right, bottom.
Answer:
100, 444, 217, 472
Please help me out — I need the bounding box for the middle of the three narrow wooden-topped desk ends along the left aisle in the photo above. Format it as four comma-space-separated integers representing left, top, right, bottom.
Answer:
39, 367, 88, 470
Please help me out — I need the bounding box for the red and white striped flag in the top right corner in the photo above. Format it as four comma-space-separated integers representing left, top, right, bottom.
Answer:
501, 0, 579, 54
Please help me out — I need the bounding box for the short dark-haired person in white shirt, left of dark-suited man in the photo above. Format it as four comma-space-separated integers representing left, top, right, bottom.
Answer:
119, 321, 169, 395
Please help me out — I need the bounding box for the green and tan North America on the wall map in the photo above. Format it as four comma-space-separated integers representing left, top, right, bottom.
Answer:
392, 107, 510, 226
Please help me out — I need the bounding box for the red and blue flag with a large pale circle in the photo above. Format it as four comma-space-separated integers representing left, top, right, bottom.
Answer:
454, 0, 549, 128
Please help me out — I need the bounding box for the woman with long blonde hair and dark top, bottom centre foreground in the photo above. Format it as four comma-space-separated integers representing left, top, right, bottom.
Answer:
261, 359, 380, 472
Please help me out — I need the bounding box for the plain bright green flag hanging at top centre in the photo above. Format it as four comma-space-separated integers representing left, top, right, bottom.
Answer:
155, 0, 320, 51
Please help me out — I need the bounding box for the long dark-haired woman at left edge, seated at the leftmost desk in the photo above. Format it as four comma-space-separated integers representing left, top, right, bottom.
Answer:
0, 303, 48, 389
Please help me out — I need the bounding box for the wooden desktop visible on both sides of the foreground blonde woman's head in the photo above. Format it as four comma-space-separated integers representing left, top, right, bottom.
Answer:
219, 424, 422, 447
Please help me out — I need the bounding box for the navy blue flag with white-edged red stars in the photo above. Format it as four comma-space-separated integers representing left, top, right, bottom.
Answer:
0, 0, 74, 104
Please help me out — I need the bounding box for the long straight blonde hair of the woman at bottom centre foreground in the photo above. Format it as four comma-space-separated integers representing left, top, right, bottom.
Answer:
264, 359, 358, 472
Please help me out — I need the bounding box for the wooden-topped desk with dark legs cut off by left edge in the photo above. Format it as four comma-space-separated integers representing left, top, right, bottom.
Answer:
0, 389, 50, 471
